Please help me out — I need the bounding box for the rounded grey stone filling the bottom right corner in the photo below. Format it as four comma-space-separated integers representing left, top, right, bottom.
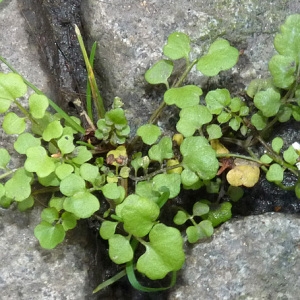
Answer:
168, 213, 300, 300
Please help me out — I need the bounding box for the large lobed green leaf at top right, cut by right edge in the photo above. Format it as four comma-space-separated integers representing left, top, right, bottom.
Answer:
274, 14, 300, 64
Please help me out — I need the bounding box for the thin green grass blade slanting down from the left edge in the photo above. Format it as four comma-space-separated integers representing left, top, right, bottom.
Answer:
0, 56, 85, 134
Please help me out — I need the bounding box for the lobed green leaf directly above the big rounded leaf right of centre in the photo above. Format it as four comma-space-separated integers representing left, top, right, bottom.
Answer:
176, 105, 212, 137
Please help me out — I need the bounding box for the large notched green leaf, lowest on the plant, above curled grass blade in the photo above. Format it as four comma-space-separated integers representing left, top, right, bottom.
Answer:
136, 224, 185, 280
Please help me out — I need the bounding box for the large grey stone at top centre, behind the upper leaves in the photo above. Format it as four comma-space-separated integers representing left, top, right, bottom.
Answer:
81, 0, 299, 124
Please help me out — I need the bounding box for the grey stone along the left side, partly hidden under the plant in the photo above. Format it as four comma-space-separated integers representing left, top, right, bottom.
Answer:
0, 0, 96, 300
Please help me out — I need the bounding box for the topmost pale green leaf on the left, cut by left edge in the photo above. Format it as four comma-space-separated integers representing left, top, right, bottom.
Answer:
0, 73, 27, 113
